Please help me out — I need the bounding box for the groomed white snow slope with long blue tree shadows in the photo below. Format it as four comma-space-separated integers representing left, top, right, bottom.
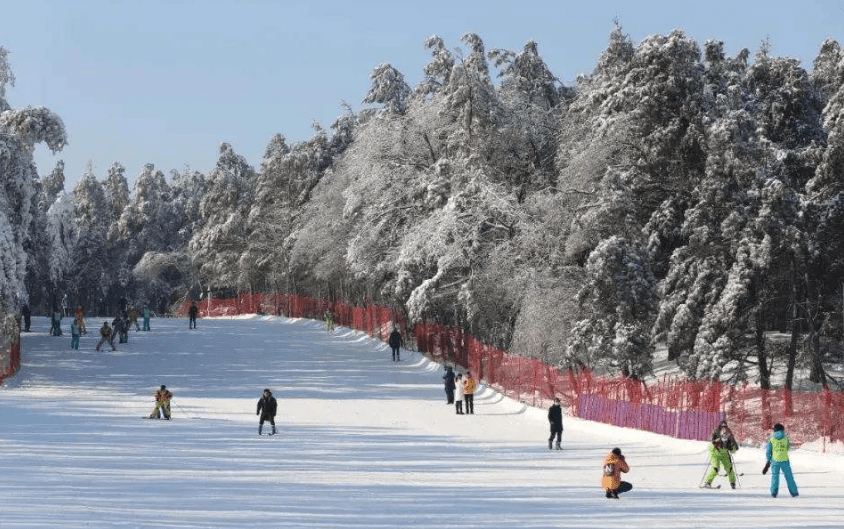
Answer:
0, 316, 844, 529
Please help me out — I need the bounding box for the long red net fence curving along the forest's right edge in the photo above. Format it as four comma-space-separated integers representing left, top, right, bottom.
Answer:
176, 294, 844, 451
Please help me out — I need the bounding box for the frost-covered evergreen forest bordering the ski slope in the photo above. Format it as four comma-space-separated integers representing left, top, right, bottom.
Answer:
0, 25, 844, 389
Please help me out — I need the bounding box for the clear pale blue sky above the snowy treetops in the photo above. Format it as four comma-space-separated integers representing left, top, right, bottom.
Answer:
0, 0, 844, 190
